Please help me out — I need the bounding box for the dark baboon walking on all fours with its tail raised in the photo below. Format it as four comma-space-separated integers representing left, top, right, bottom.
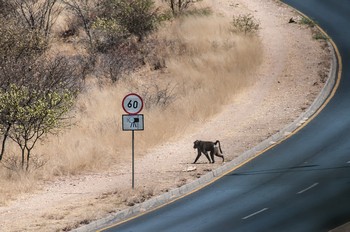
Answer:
193, 140, 224, 164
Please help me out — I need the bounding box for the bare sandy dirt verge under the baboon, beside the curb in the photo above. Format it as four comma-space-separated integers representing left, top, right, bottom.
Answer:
0, 0, 330, 231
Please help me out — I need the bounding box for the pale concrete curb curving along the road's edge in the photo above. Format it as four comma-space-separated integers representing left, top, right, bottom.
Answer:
73, 42, 337, 232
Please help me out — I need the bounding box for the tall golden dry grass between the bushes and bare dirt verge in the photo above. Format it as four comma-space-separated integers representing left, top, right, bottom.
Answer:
0, 16, 262, 203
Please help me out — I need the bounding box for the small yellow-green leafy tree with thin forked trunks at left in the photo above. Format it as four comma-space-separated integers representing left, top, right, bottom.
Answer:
0, 84, 74, 170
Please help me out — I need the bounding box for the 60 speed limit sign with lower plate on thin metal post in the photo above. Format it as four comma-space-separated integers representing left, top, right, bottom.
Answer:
122, 93, 144, 189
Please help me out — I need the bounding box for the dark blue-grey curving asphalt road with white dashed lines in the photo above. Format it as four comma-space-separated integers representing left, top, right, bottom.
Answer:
104, 0, 350, 232
